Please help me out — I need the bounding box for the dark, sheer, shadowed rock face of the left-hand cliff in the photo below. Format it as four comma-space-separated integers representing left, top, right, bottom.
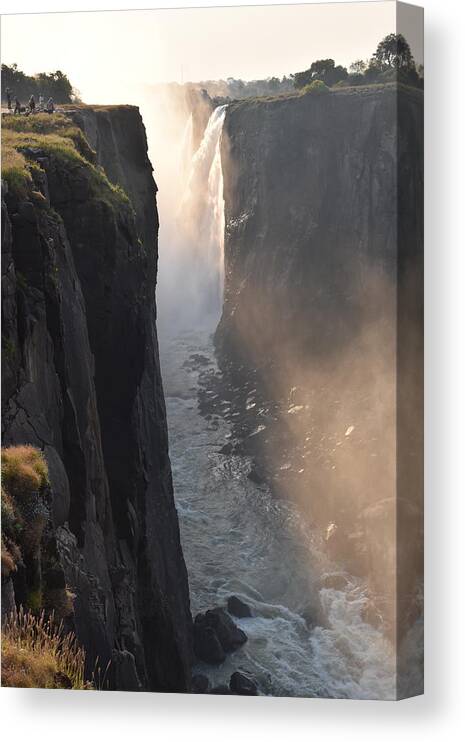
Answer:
2, 107, 191, 691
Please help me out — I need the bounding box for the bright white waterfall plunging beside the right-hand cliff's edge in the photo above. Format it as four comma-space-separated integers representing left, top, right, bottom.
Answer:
178, 106, 227, 321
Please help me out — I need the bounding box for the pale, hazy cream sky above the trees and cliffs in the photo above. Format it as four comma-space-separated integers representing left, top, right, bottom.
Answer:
1, 2, 422, 103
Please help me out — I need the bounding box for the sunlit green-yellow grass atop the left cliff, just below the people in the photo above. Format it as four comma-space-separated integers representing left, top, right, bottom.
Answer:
2, 113, 129, 207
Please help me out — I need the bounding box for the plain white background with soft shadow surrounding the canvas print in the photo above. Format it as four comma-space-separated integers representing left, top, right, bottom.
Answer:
0, 0, 465, 742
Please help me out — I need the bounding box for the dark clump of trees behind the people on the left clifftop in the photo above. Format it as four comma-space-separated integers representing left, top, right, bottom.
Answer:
2, 64, 78, 104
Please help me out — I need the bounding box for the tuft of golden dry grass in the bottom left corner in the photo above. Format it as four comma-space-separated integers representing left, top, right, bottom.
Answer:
2, 609, 93, 690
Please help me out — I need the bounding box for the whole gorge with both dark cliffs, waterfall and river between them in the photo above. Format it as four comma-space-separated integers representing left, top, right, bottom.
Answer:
2, 84, 423, 699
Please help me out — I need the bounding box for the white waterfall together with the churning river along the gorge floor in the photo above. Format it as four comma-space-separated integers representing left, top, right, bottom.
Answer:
160, 107, 416, 699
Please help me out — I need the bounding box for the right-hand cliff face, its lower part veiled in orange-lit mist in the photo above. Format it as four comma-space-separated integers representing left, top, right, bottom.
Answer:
216, 86, 423, 676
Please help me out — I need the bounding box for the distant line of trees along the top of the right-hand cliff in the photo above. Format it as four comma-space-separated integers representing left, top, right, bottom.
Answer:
190, 33, 423, 99
